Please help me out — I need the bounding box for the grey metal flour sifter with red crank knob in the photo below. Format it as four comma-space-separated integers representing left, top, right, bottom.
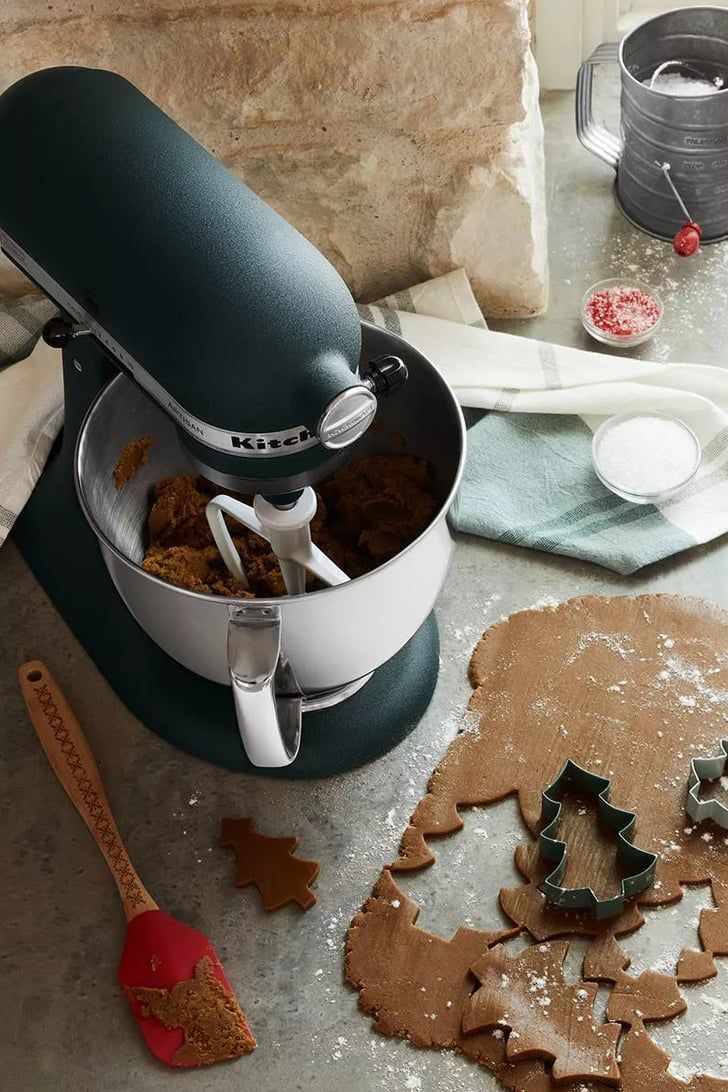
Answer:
576, 7, 728, 242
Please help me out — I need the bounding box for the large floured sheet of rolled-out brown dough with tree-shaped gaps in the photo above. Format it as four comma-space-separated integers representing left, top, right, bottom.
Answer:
346, 595, 728, 1092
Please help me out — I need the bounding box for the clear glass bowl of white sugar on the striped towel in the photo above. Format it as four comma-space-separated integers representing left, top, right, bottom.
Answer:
592, 412, 702, 505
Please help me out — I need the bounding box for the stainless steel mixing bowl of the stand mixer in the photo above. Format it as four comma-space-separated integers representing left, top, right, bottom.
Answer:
75, 323, 465, 765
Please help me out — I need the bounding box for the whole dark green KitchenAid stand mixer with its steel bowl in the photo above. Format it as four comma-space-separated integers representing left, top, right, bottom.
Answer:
0, 68, 464, 776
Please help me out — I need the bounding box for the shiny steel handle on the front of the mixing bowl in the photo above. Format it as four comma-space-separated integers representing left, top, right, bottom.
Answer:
227, 604, 301, 768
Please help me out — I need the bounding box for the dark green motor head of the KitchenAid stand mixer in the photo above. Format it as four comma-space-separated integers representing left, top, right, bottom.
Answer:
0, 67, 406, 495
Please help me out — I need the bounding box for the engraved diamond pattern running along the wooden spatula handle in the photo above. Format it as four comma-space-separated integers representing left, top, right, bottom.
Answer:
33, 683, 145, 910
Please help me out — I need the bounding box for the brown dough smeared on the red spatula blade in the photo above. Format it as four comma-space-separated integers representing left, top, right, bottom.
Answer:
127, 956, 255, 1066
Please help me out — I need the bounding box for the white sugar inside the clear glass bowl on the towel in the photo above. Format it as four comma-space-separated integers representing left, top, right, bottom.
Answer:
596, 414, 700, 496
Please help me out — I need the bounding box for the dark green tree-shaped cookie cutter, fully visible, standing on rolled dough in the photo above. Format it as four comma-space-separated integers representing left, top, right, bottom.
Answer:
538, 759, 657, 918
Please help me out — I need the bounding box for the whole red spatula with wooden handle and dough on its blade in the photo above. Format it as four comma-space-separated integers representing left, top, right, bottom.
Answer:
19, 660, 255, 1066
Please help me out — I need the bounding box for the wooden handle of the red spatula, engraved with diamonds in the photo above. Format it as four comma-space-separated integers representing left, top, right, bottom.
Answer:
17, 660, 158, 922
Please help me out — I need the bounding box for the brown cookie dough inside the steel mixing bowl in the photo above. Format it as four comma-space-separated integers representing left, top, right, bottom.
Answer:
144, 454, 438, 598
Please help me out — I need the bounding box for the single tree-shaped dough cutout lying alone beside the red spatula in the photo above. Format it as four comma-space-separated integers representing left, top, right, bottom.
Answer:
217, 819, 320, 910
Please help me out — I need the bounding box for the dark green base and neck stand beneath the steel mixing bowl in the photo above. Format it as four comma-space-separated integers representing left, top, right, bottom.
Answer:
12, 339, 440, 778
